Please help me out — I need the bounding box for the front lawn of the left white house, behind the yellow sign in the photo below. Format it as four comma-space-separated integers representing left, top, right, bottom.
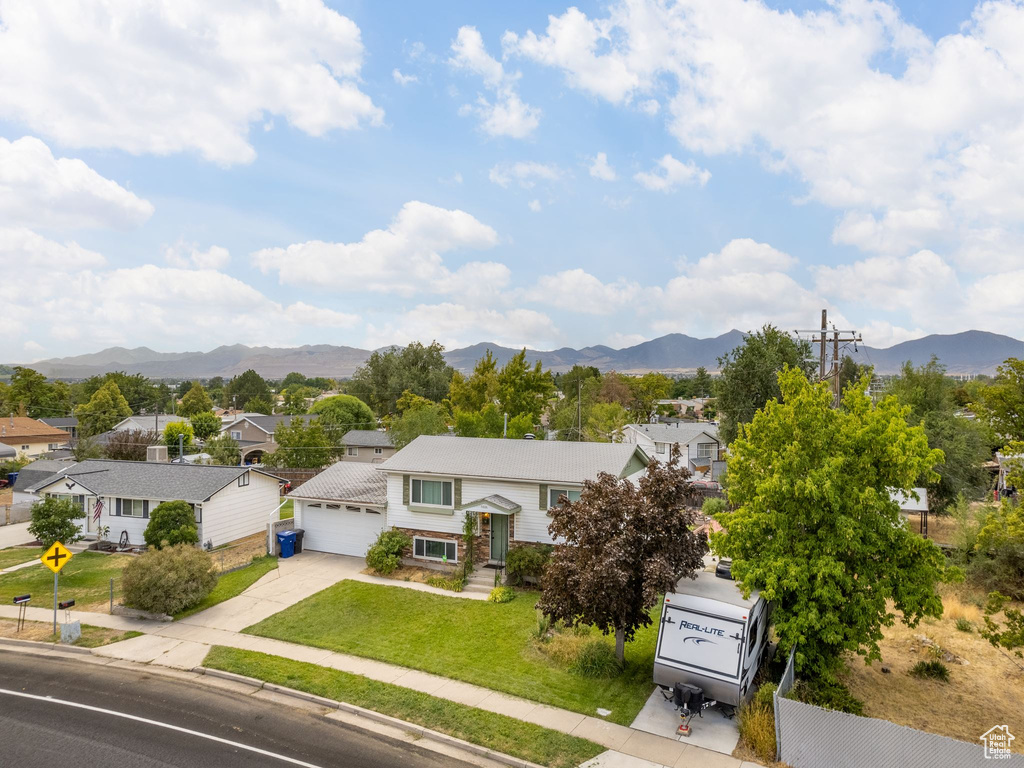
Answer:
0, 552, 131, 610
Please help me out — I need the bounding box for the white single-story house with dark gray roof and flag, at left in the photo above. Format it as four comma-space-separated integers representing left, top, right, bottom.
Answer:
29, 459, 280, 547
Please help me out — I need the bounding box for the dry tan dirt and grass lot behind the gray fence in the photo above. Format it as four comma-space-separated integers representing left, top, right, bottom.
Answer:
845, 590, 1024, 754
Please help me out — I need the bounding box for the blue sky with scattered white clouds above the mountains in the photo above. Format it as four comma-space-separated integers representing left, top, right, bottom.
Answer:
0, 0, 1024, 361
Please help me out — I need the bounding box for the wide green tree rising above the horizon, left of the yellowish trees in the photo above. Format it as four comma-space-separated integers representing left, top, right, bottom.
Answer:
346, 341, 453, 416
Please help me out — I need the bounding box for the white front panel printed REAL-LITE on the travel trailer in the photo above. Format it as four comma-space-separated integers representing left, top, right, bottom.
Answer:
655, 603, 744, 679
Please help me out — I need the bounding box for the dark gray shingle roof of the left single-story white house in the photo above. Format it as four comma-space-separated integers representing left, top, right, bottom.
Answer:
24, 459, 276, 503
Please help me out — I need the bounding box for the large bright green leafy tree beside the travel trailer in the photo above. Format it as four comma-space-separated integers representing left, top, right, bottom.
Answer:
712, 369, 945, 681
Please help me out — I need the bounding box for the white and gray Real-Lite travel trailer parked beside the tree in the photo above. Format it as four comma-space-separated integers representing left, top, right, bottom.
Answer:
654, 571, 770, 707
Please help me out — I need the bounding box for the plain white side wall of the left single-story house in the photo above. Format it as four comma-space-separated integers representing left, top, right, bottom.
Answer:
200, 472, 281, 547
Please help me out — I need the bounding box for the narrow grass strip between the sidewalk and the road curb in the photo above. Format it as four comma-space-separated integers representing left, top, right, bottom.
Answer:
203, 646, 604, 768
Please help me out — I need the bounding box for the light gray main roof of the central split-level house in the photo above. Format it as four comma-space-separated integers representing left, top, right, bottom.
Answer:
376, 435, 646, 483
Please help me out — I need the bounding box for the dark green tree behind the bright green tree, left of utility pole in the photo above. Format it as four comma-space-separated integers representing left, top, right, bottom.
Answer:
715, 325, 815, 443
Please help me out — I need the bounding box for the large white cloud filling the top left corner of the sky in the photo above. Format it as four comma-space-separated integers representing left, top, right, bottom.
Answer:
0, 0, 383, 165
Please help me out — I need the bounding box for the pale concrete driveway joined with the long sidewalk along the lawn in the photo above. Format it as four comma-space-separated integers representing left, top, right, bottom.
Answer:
0, 553, 755, 768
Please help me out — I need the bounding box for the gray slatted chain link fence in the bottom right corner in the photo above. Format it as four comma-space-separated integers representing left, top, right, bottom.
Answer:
774, 650, 1024, 768
